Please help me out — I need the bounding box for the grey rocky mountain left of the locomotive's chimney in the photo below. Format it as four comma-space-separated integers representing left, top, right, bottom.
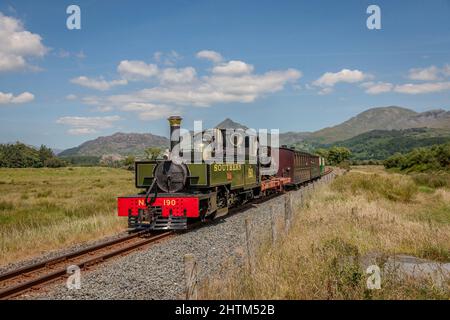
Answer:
58, 132, 169, 157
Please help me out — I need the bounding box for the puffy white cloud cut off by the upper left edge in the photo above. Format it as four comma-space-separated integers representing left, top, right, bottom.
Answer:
0, 12, 48, 72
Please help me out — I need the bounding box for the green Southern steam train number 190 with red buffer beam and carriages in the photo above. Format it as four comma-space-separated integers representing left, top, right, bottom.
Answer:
118, 116, 325, 230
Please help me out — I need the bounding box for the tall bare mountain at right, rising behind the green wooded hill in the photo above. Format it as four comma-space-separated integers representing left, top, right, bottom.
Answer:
307, 106, 450, 143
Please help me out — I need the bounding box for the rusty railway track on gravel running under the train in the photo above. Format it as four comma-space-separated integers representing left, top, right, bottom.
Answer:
0, 169, 333, 300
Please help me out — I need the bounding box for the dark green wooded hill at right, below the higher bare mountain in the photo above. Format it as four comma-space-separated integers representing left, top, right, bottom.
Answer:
322, 128, 450, 160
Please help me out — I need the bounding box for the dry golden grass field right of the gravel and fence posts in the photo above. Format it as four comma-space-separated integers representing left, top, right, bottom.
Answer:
201, 166, 450, 299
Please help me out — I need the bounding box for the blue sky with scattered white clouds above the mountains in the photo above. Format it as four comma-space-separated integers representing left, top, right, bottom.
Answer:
0, 0, 450, 149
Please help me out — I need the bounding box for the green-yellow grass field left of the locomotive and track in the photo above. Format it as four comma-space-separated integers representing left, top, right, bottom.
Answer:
0, 167, 136, 265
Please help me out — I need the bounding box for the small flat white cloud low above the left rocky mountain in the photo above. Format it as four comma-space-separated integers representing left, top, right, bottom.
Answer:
56, 116, 120, 135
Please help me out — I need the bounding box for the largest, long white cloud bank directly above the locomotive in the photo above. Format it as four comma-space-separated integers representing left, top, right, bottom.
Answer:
78, 52, 302, 120
